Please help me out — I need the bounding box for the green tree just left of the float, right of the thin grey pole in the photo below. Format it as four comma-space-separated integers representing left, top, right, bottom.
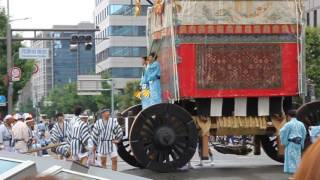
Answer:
117, 81, 140, 111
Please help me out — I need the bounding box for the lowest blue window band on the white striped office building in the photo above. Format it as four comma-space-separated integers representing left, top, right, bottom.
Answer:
108, 67, 142, 78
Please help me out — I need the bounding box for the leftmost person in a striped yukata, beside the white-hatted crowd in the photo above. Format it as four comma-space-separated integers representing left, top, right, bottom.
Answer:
50, 113, 70, 159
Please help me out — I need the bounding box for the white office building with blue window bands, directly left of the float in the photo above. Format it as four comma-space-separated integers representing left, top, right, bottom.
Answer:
94, 0, 148, 89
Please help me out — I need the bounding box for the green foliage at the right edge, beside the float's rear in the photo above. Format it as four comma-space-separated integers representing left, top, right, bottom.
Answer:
306, 28, 320, 97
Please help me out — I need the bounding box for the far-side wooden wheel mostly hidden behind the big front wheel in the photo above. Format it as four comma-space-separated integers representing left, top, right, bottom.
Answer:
117, 105, 143, 168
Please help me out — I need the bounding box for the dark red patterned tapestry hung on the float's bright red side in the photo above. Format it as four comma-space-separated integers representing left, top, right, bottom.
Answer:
196, 44, 282, 90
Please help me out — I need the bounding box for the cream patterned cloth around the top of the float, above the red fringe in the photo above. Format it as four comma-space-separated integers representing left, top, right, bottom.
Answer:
149, 0, 300, 33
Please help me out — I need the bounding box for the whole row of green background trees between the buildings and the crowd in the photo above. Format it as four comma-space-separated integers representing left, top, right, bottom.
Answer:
40, 81, 140, 117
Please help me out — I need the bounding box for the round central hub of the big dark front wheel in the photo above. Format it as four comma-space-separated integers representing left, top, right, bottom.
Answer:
154, 126, 176, 148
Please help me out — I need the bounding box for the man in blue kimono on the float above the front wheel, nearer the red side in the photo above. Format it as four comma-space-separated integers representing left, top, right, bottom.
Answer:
145, 53, 161, 106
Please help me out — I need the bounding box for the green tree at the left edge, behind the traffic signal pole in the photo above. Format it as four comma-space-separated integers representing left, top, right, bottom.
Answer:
0, 11, 34, 114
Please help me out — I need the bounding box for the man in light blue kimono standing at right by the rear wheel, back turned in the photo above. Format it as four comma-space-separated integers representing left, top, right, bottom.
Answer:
280, 110, 307, 179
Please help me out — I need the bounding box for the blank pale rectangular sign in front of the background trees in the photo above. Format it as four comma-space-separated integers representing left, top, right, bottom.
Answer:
77, 75, 102, 96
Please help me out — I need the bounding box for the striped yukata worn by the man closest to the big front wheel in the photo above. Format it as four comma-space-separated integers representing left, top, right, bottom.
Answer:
92, 118, 123, 156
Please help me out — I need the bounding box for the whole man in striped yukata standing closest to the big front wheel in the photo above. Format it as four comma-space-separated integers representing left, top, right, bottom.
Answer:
92, 109, 123, 171
